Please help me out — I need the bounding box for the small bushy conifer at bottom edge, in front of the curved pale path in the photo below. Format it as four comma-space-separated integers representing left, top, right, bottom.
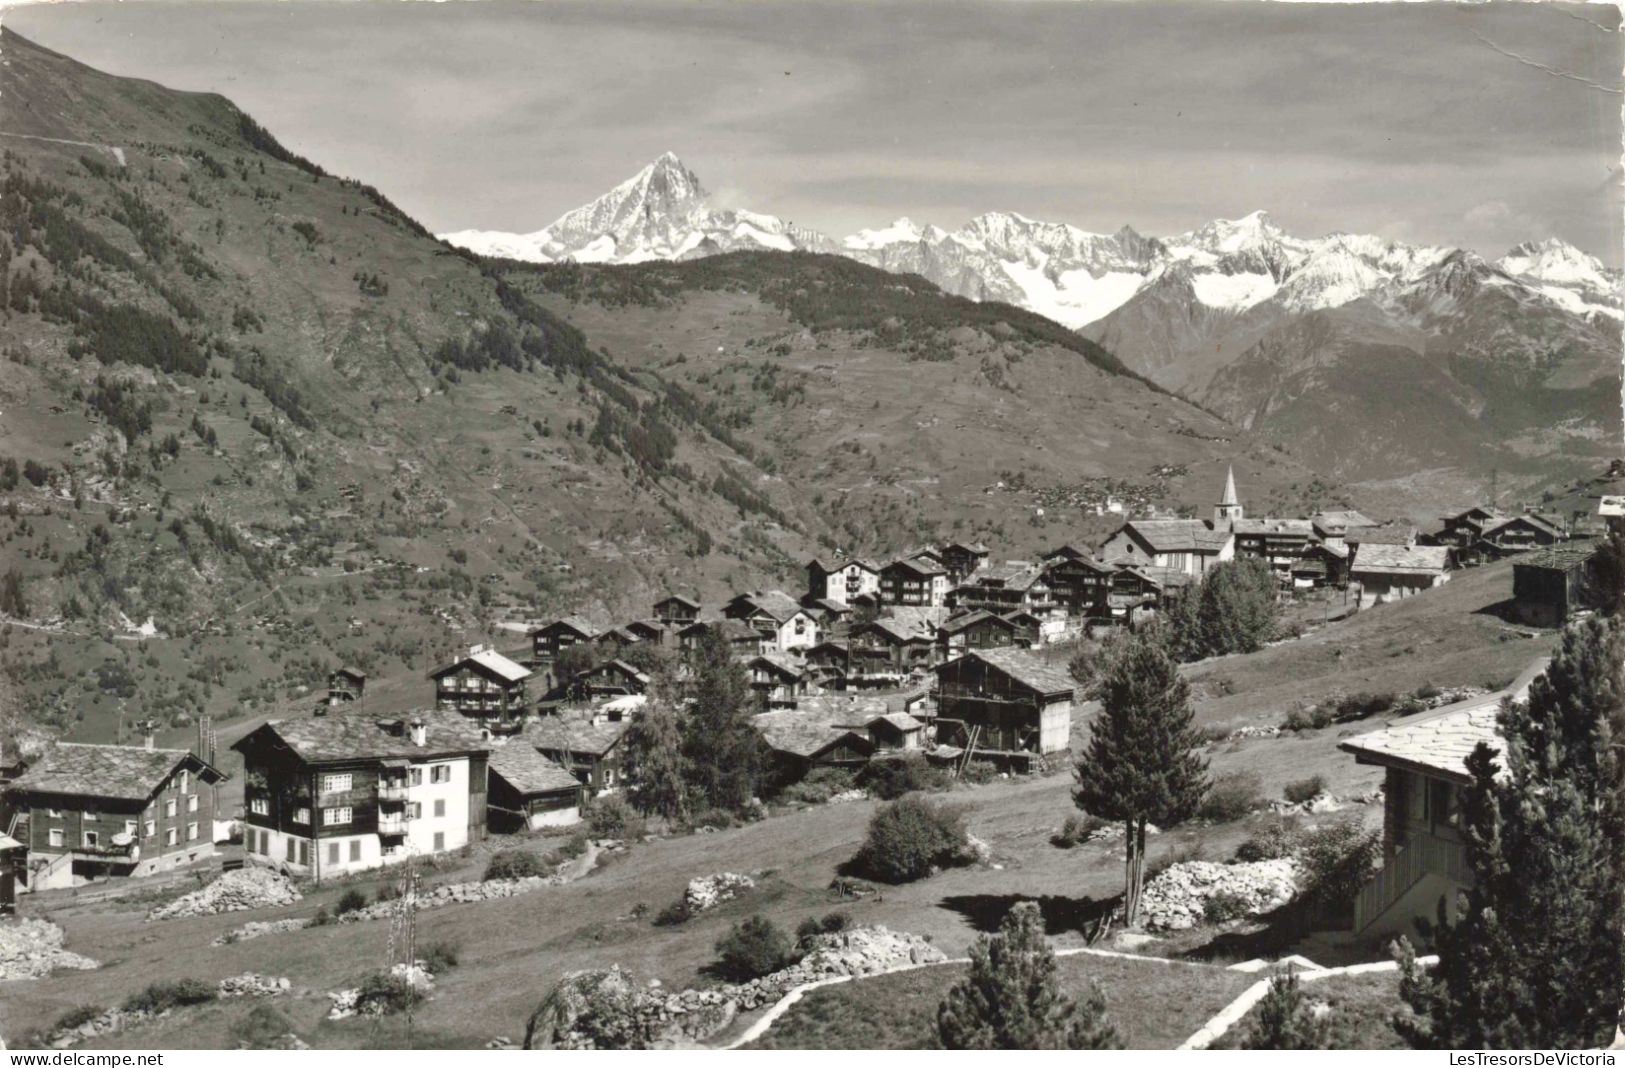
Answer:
936, 901, 1123, 1050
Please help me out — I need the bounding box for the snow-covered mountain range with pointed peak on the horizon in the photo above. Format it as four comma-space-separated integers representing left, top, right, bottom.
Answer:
440, 153, 1625, 328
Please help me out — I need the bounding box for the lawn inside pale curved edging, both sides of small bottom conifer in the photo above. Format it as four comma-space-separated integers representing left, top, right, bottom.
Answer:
751, 953, 1256, 1050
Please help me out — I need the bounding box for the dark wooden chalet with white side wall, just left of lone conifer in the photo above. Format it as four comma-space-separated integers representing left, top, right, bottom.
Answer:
936, 649, 1074, 767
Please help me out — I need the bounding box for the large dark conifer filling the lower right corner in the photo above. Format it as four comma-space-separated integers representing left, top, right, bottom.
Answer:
1396, 618, 1625, 1048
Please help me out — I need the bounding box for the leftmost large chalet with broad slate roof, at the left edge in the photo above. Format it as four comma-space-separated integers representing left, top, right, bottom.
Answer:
0, 741, 226, 891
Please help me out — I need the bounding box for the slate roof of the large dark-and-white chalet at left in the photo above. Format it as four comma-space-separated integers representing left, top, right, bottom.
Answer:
231, 712, 492, 764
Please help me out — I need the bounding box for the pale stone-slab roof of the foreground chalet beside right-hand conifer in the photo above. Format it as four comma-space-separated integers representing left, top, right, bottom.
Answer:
1337, 657, 1550, 784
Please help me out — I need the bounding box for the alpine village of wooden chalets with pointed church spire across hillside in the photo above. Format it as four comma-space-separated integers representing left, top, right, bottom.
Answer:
0, 473, 1625, 1042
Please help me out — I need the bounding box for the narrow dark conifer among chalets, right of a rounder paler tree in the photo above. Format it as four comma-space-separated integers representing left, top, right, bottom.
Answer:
683, 634, 762, 811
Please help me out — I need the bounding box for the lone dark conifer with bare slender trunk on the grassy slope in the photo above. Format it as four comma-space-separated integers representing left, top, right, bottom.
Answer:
1073, 636, 1207, 925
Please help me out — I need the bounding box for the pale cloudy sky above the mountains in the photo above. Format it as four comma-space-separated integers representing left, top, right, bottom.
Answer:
12, 0, 1622, 265
